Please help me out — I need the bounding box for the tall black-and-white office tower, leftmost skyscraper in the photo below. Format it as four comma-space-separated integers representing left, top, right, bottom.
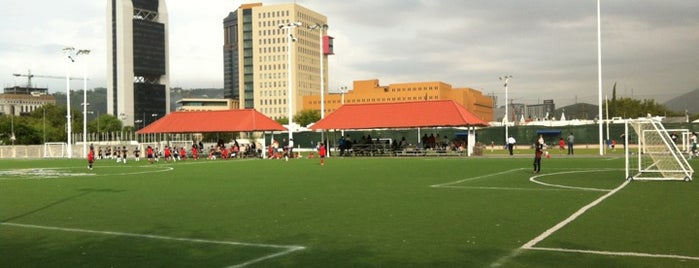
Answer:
107, 0, 170, 129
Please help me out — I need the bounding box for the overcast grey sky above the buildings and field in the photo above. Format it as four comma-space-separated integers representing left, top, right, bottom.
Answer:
0, 0, 699, 107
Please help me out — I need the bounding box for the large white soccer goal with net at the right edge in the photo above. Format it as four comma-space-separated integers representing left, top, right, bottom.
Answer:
624, 118, 694, 181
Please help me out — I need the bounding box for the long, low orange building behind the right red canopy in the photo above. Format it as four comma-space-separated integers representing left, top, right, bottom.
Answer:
303, 79, 493, 122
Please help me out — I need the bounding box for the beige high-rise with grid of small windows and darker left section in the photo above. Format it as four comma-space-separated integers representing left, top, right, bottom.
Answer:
223, 3, 332, 119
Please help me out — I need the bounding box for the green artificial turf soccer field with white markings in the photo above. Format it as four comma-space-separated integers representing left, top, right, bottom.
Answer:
0, 156, 699, 267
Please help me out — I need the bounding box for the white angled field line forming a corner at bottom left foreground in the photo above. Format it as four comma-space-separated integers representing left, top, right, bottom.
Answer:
0, 222, 306, 268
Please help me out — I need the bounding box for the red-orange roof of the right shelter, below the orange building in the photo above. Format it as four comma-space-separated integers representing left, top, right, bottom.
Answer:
310, 100, 488, 130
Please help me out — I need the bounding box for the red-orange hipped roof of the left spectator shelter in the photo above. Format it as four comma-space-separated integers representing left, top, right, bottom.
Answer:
136, 109, 286, 134
